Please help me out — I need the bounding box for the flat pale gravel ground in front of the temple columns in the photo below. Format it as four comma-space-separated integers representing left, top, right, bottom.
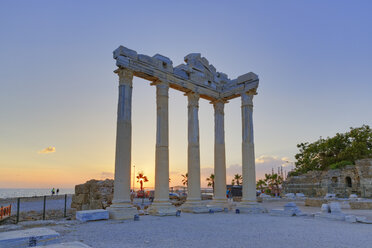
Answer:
51, 213, 372, 248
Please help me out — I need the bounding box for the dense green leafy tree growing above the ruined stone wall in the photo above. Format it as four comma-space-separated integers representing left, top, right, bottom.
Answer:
291, 125, 372, 175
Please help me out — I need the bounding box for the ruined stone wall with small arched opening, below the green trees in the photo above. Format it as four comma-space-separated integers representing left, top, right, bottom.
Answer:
283, 159, 372, 198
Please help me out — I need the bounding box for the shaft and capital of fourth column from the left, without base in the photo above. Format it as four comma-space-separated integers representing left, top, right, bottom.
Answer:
213, 100, 227, 203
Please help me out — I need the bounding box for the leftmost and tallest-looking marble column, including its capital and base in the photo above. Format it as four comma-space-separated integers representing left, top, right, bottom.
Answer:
108, 69, 137, 219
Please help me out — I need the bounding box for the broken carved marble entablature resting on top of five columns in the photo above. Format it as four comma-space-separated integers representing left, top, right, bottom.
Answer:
114, 46, 259, 101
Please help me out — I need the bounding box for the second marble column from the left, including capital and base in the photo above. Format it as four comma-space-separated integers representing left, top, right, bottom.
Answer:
148, 81, 176, 215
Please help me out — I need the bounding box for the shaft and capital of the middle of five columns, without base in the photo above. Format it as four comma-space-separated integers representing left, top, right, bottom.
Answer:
187, 92, 201, 201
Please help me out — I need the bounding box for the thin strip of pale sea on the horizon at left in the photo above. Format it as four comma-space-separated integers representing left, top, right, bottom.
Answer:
0, 188, 74, 199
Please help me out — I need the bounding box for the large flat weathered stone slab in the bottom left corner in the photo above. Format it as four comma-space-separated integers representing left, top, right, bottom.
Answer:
0, 228, 59, 248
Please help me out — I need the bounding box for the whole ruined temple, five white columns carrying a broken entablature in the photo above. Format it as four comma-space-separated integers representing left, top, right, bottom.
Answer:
109, 46, 259, 219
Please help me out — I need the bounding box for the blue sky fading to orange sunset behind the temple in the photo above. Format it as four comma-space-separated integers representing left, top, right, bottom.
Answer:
0, 0, 372, 188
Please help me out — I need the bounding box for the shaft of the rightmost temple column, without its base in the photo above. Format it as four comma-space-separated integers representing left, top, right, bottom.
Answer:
241, 93, 256, 201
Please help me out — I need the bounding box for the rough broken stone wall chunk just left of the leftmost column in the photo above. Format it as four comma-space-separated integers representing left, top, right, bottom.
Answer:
71, 179, 114, 211
